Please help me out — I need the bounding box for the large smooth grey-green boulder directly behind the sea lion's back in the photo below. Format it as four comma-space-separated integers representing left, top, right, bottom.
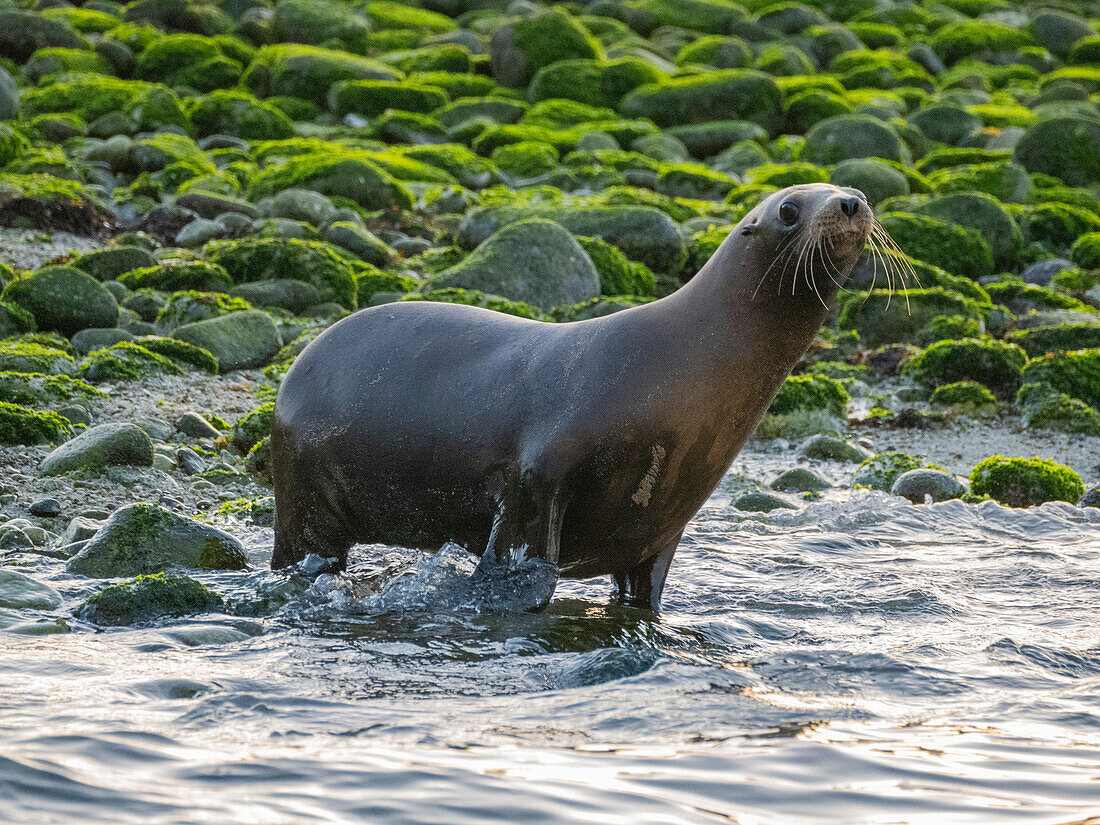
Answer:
431, 218, 600, 311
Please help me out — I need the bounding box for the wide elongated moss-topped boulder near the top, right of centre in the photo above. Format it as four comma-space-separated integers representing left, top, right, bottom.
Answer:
619, 69, 783, 134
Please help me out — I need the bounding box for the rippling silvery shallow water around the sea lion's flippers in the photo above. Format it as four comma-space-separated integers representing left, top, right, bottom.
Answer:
0, 492, 1100, 825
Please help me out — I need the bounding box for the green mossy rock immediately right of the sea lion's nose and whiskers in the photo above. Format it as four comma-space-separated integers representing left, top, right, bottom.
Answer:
879, 212, 993, 279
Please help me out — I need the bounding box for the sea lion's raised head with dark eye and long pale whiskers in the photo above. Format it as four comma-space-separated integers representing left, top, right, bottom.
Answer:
733, 184, 877, 304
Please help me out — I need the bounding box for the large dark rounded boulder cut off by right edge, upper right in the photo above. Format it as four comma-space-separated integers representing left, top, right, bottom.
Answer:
1015, 117, 1100, 186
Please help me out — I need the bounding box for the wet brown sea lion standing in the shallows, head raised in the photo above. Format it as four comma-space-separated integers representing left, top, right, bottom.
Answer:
272, 189, 875, 608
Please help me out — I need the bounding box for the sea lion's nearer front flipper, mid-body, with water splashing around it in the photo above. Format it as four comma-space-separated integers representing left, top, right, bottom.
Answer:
474, 473, 562, 611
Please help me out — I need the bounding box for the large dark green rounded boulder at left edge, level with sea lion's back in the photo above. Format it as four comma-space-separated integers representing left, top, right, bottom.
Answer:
0, 266, 119, 336
